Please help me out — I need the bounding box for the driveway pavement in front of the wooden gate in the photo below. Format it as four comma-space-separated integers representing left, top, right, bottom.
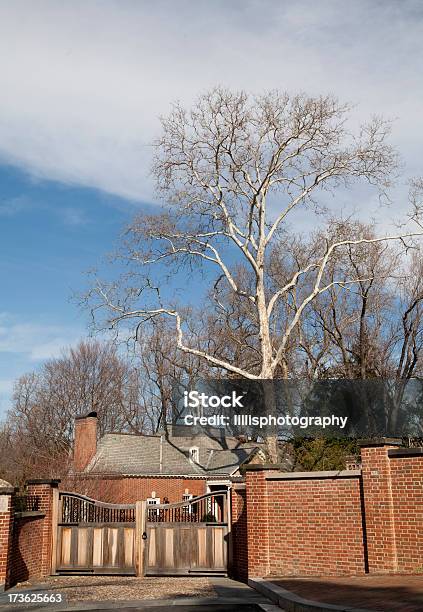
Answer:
0, 576, 280, 612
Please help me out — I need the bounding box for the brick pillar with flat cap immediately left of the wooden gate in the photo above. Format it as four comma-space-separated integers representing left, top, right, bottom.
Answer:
26, 479, 60, 576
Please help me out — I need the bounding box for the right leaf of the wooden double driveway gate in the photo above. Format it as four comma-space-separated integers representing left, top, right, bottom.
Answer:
142, 491, 229, 576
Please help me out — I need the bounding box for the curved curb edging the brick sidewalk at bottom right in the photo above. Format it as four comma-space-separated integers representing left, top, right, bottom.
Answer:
248, 578, 375, 612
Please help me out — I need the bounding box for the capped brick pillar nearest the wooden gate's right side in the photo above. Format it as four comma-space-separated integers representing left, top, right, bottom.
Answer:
245, 465, 280, 578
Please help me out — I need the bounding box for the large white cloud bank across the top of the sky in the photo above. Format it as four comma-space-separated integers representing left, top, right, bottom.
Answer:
0, 0, 423, 207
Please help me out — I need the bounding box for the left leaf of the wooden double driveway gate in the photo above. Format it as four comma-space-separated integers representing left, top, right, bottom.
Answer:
55, 491, 136, 575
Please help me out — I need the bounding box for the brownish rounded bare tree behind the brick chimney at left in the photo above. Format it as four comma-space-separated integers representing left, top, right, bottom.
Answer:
1, 341, 147, 481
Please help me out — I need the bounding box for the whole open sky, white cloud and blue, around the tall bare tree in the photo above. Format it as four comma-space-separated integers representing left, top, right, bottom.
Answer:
0, 0, 423, 413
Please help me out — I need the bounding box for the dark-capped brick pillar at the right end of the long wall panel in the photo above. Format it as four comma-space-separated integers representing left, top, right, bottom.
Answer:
360, 438, 401, 574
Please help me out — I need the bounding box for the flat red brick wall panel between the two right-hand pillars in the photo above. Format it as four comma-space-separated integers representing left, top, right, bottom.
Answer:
267, 470, 365, 576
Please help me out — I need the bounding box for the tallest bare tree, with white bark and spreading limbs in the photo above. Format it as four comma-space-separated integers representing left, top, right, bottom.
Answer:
90, 88, 421, 461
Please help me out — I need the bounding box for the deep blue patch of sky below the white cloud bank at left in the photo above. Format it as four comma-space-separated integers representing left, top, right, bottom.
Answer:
0, 165, 147, 410
